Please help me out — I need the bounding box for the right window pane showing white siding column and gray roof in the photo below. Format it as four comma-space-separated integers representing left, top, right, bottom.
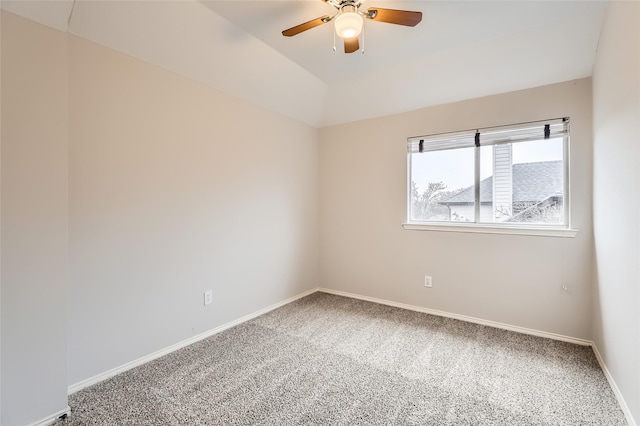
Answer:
480, 138, 564, 224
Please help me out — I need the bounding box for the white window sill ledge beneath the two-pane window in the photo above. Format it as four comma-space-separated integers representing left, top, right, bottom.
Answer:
402, 223, 578, 238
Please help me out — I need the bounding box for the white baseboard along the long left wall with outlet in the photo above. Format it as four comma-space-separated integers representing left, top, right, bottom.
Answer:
67, 287, 318, 395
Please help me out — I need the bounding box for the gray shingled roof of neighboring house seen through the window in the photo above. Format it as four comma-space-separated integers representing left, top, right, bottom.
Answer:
440, 161, 564, 204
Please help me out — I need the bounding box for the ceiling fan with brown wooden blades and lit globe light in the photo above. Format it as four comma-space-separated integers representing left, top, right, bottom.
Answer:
282, 0, 422, 53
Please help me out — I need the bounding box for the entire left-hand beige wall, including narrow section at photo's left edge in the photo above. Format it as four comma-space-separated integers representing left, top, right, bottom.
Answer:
0, 12, 318, 425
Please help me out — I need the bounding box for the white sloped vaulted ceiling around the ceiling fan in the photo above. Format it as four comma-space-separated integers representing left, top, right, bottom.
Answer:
2, 0, 607, 127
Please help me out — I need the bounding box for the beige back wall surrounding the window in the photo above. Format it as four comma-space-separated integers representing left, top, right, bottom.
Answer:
320, 79, 593, 339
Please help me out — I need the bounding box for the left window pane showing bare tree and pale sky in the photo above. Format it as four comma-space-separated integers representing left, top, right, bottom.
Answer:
409, 148, 475, 222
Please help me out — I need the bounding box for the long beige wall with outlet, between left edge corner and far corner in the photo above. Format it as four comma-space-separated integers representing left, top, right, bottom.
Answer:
68, 36, 318, 384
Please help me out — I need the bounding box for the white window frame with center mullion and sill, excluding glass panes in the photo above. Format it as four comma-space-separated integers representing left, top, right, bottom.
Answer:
402, 117, 578, 238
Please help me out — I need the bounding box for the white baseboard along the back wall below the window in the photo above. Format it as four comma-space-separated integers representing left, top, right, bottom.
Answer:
318, 287, 593, 346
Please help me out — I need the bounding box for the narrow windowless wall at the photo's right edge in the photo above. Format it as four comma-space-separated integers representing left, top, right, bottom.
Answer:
593, 2, 640, 424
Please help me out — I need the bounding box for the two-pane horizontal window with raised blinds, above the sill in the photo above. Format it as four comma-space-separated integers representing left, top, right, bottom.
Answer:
405, 118, 575, 235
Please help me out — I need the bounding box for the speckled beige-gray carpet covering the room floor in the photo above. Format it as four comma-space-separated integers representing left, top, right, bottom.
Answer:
58, 293, 626, 426
